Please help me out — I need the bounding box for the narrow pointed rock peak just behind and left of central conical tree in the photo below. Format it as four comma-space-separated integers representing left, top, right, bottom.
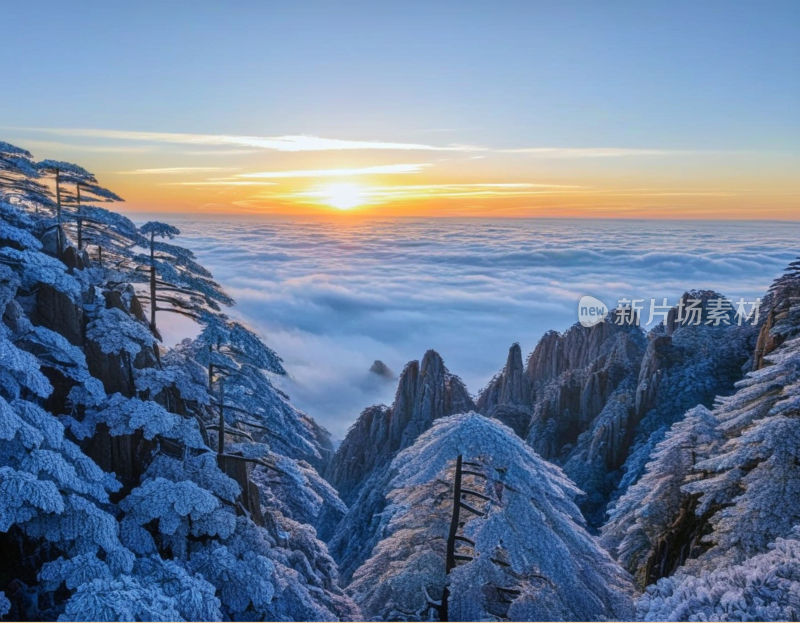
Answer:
327, 350, 474, 504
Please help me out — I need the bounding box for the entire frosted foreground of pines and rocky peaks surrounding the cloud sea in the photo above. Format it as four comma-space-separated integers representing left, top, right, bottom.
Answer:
0, 142, 800, 621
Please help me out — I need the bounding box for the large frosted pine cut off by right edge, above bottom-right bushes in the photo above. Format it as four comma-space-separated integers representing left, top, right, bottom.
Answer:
685, 338, 800, 561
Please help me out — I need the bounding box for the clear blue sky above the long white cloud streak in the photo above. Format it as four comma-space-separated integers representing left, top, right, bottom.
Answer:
0, 0, 800, 218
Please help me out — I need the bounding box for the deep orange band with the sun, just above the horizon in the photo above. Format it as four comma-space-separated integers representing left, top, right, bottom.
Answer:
109, 169, 800, 220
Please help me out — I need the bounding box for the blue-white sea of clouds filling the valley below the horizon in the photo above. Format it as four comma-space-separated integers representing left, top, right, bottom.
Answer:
164, 218, 800, 439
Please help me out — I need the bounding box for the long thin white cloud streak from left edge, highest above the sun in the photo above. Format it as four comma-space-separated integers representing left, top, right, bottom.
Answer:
6, 128, 484, 152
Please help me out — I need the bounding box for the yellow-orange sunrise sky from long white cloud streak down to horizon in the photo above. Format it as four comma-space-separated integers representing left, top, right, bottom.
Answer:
3, 130, 800, 221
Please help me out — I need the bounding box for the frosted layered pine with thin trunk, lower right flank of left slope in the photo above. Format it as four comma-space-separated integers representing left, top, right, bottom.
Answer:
173, 313, 346, 537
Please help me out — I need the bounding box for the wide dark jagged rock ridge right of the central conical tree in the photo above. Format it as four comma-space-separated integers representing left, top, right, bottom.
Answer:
477, 298, 756, 526
